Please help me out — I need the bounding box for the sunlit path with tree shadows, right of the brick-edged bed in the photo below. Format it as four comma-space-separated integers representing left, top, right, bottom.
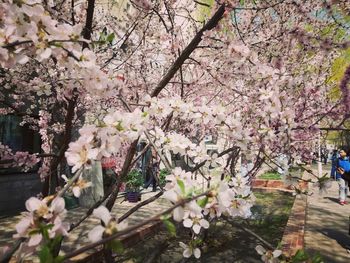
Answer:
305, 165, 350, 263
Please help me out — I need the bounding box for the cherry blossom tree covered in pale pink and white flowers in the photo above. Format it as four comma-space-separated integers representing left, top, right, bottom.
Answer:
0, 0, 350, 262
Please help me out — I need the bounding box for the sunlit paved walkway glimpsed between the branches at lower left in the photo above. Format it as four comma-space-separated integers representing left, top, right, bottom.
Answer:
0, 192, 170, 258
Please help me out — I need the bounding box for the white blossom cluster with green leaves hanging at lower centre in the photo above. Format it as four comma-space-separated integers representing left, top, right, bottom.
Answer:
164, 167, 254, 258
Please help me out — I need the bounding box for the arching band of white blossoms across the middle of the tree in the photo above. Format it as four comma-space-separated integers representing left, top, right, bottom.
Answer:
66, 97, 248, 172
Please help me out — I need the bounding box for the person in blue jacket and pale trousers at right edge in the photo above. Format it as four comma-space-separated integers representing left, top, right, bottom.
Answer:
336, 149, 350, 205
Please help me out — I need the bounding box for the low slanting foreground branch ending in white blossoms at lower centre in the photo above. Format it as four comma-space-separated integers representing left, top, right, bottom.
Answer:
64, 161, 251, 259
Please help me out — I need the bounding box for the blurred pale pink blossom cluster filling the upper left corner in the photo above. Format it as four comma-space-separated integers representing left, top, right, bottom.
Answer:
0, 0, 114, 96
